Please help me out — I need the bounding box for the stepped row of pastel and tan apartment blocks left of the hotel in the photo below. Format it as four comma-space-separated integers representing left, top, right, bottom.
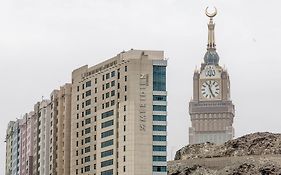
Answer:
5, 84, 71, 175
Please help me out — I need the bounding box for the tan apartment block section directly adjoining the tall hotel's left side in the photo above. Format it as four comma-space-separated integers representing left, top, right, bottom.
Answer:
49, 84, 71, 175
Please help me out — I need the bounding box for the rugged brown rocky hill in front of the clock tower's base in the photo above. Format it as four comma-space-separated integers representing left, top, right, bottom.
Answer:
168, 133, 281, 175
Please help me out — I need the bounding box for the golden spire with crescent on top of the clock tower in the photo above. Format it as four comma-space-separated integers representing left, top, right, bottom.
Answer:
205, 7, 217, 50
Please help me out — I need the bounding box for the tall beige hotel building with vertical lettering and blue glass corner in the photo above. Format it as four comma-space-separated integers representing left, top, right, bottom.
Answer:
71, 50, 167, 175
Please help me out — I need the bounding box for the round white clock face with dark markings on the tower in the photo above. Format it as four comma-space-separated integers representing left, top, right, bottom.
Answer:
201, 80, 220, 99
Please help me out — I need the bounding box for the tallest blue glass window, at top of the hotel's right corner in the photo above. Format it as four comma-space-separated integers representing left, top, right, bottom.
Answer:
153, 66, 166, 91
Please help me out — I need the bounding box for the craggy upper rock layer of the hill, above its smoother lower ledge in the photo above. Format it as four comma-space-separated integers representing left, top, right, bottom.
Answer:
175, 132, 281, 160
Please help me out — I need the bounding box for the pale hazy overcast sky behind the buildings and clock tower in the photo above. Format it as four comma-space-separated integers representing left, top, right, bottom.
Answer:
0, 0, 281, 174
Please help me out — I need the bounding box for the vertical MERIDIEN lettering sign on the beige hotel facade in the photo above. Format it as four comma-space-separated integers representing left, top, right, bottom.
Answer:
139, 74, 148, 132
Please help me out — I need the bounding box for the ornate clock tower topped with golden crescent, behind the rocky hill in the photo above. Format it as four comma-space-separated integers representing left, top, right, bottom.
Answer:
189, 8, 235, 144
